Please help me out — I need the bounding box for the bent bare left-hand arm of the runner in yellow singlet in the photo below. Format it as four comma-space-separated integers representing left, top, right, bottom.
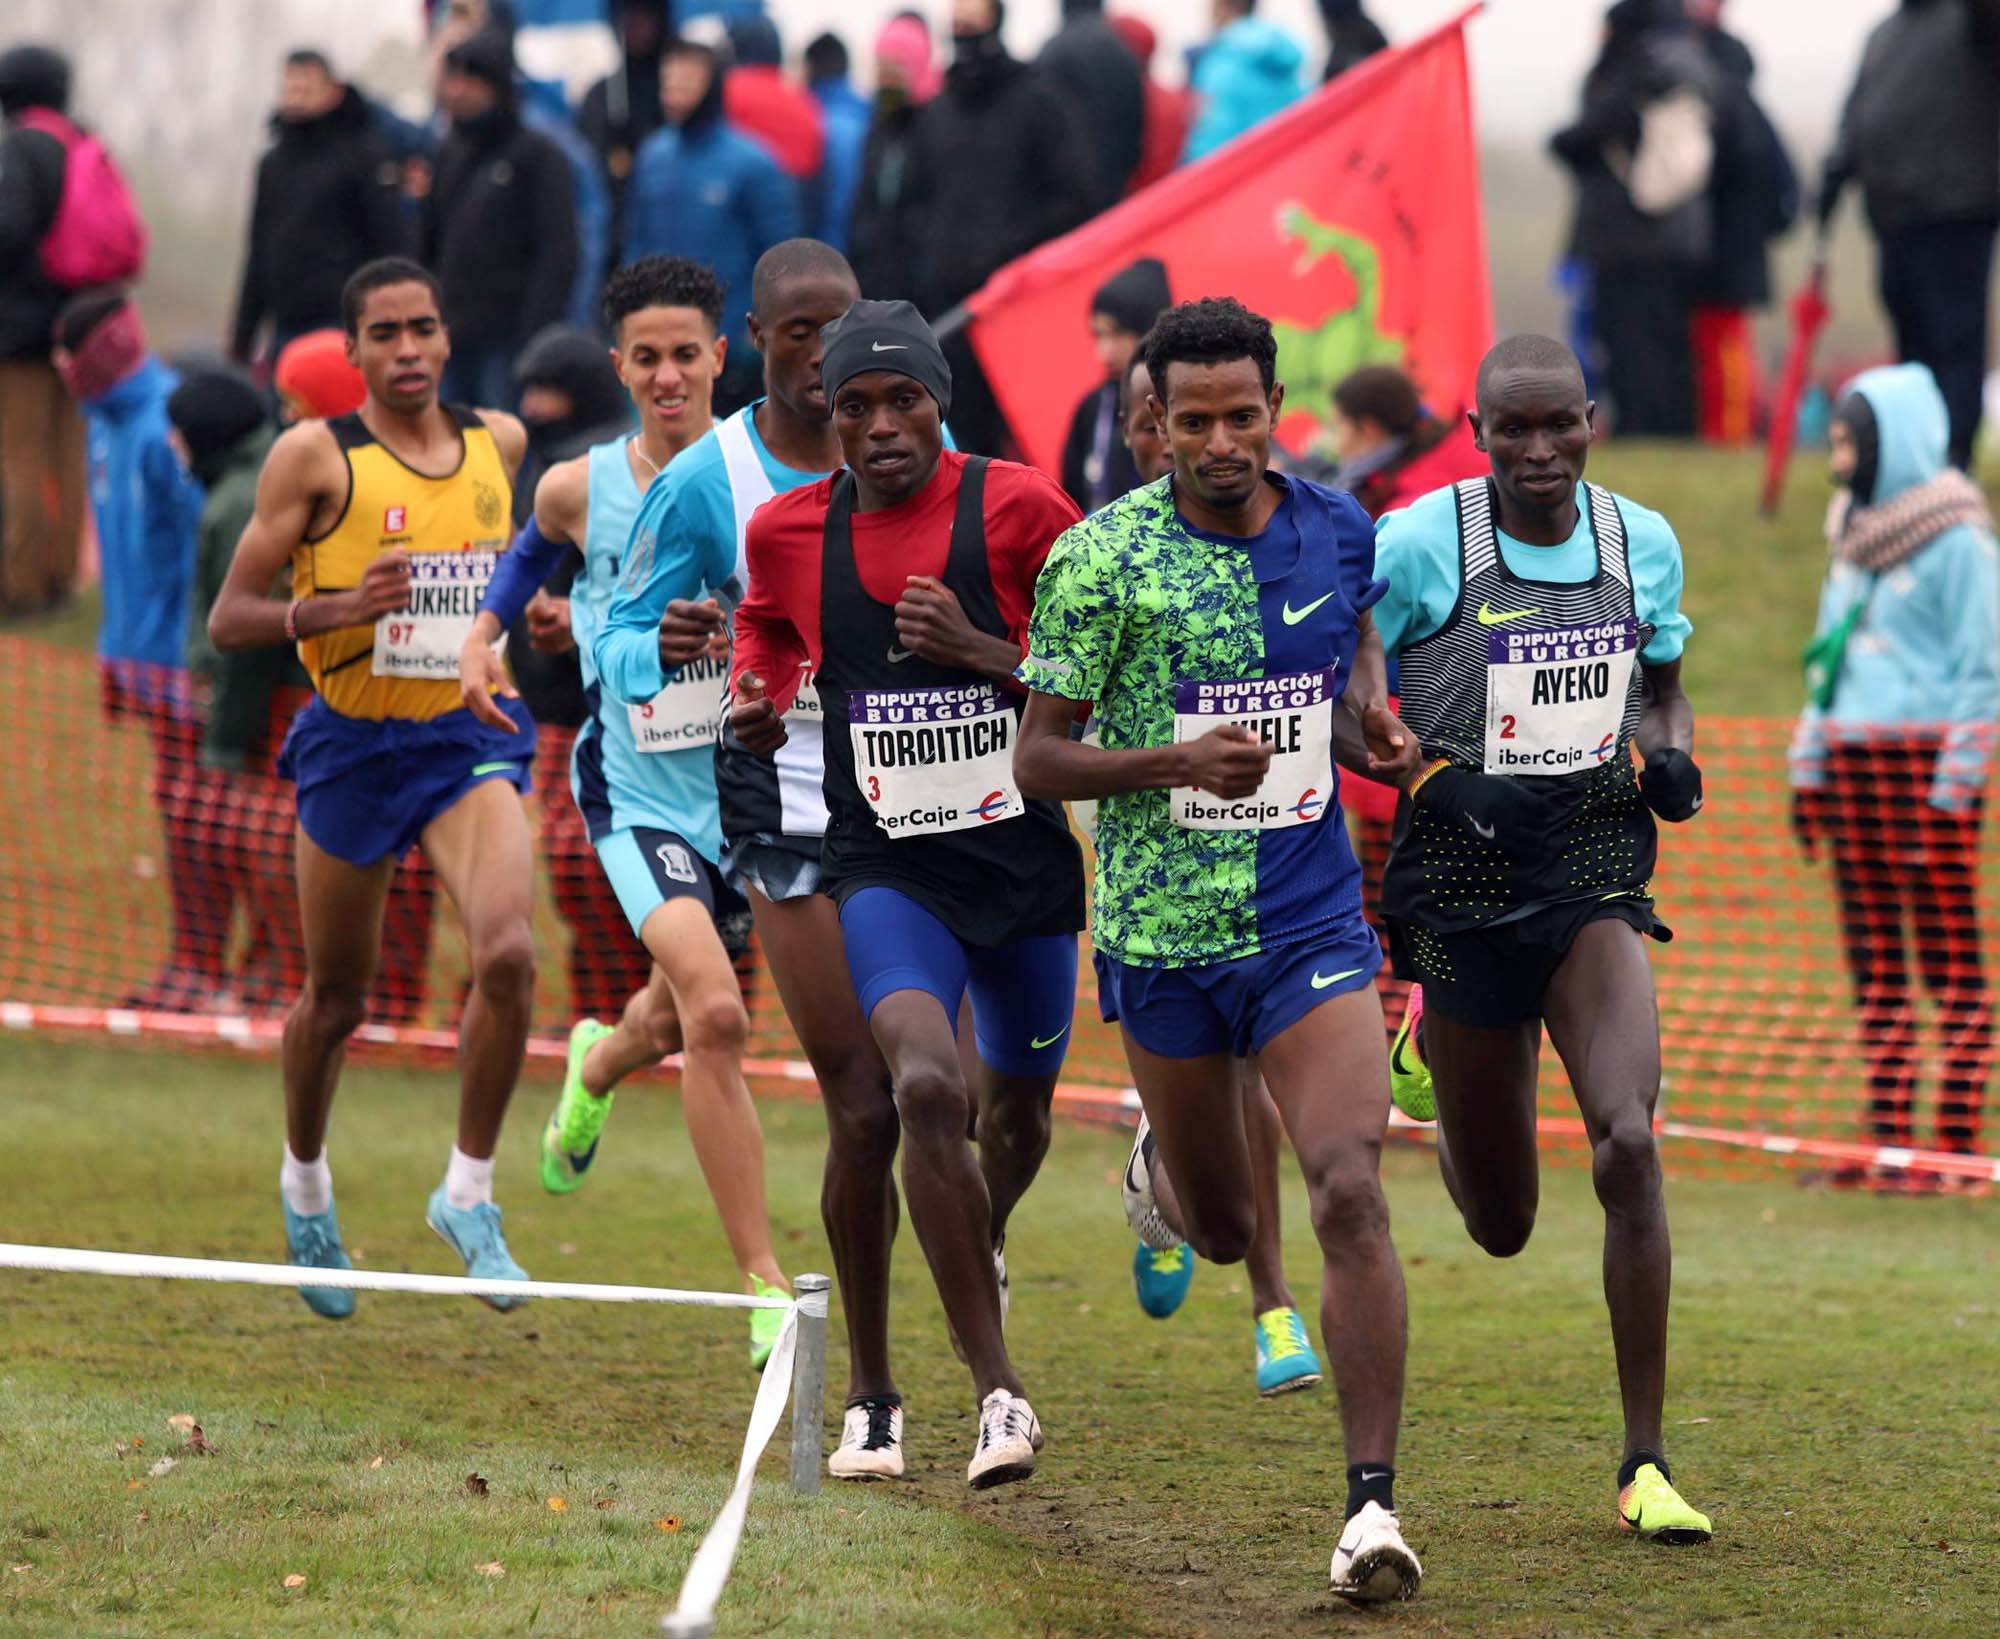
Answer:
208, 422, 410, 650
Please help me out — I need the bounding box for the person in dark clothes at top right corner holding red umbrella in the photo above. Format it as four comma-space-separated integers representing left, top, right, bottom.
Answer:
1820, 0, 2000, 468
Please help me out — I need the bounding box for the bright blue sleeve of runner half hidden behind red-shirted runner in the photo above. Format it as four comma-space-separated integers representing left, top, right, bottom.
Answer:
592, 466, 736, 706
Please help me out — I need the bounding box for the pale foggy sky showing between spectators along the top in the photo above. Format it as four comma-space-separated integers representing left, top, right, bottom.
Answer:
0, 0, 1894, 354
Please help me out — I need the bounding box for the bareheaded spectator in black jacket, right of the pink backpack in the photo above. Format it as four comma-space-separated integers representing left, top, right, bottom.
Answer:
230, 52, 406, 360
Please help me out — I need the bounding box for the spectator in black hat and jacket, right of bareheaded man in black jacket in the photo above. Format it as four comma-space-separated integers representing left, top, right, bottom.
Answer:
422, 28, 580, 406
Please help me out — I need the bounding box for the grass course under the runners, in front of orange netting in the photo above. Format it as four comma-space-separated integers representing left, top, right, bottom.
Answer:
0, 1037, 2000, 1639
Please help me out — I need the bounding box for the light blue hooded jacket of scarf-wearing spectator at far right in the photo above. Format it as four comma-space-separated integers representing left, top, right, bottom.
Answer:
1792, 364, 2000, 812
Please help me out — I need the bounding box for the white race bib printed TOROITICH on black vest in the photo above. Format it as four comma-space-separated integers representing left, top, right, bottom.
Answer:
848, 684, 1026, 837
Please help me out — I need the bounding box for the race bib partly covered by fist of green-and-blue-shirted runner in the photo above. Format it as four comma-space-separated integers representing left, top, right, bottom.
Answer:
1172, 666, 1338, 831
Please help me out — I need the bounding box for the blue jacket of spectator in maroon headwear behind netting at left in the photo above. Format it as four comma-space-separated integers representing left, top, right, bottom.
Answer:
84, 356, 202, 700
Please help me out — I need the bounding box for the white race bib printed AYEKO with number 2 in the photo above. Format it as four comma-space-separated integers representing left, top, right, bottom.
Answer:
1486, 618, 1640, 774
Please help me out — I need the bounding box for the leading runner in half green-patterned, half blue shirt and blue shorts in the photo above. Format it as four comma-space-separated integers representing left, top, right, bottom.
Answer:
1014, 300, 1422, 1601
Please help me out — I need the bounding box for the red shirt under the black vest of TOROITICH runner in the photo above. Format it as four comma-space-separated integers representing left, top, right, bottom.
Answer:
732, 450, 1082, 712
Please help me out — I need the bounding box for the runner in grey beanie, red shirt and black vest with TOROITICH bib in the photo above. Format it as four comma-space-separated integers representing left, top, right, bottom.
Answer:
730, 302, 1084, 1487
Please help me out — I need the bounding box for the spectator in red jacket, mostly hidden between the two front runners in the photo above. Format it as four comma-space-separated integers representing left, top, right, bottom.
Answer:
1332, 364, 1486, 1029
